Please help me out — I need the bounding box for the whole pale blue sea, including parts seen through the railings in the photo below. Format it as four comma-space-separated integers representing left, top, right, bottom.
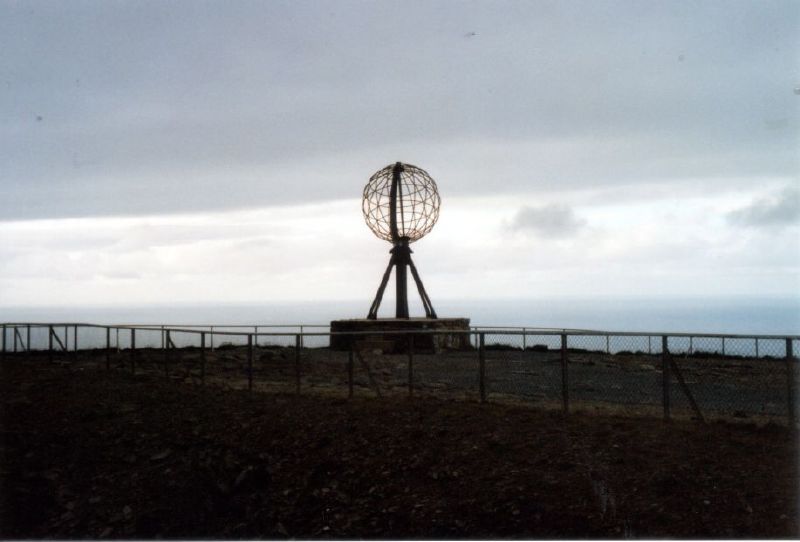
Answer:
0, 297, 800, 357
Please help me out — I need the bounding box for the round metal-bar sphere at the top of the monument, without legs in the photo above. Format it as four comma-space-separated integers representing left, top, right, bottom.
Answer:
361, 164, 441, 243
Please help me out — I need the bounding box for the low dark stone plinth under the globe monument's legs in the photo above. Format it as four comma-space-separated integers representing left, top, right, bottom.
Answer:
330, 318, 472, 354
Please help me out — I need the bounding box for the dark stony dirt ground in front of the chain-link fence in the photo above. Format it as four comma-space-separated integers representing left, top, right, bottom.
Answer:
0, 360, 800, 539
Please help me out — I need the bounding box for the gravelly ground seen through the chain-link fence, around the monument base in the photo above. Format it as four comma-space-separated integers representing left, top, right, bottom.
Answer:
37, 347, 800, 424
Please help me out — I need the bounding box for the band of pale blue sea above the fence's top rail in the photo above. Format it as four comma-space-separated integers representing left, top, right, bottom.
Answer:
0, 296, 800, 335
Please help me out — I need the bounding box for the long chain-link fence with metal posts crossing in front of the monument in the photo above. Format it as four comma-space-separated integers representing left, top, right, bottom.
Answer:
0, 323, 800, 423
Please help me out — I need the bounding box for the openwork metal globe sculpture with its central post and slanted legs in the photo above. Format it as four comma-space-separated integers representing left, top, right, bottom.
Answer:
361, 162, 441, 320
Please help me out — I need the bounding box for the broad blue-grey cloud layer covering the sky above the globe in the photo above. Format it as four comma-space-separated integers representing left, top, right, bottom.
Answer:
0, 0, 800, 220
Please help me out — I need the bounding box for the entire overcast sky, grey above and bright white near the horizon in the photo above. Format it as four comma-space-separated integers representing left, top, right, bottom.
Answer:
0, 0, 800, 308
